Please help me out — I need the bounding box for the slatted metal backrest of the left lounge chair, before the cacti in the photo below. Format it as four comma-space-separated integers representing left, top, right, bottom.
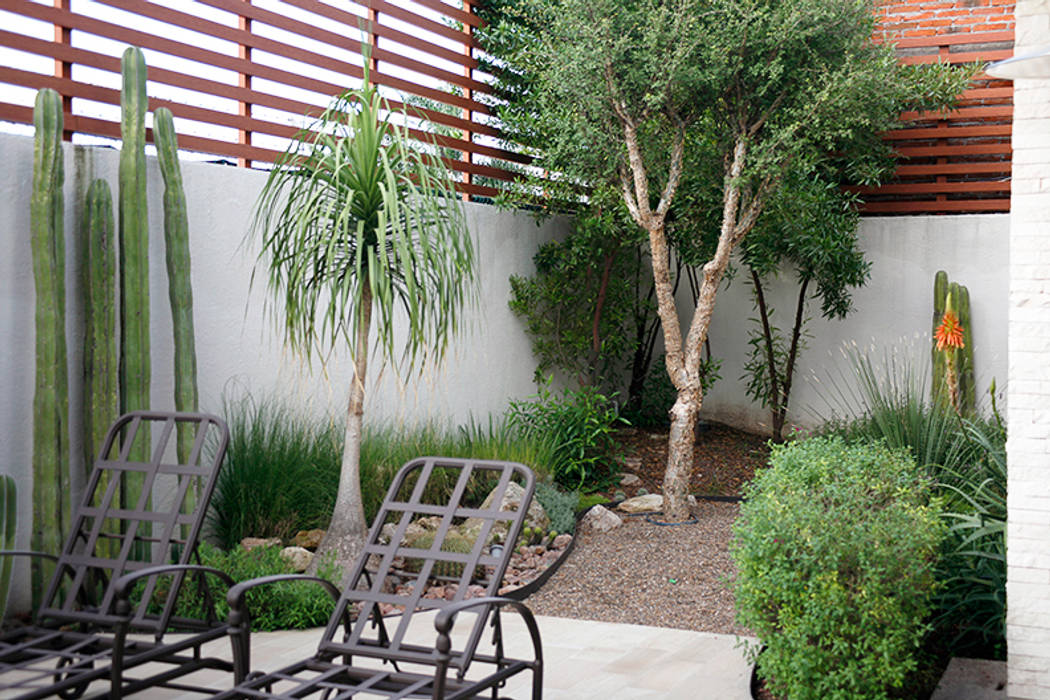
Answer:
38, 411, 229, 633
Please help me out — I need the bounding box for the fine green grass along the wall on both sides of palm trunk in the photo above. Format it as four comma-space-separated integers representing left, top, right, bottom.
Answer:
208, 395, 554, 549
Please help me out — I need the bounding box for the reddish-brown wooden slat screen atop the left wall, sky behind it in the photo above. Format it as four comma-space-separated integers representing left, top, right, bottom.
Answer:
0, 0, 528, 196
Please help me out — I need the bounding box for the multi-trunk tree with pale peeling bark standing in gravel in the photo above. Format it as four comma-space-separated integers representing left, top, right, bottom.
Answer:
482, 0, 970, 521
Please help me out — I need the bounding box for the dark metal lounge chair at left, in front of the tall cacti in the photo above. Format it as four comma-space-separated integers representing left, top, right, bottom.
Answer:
0, 411, 233, 700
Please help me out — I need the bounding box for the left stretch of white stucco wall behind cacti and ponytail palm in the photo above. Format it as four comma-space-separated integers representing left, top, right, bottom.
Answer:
0, 128, 567, 607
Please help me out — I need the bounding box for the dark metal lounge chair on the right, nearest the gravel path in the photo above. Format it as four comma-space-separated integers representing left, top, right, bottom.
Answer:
218, 458, 543, 700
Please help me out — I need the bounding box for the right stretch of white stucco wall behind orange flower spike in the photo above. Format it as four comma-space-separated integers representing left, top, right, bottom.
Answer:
697, 214, 1010, 431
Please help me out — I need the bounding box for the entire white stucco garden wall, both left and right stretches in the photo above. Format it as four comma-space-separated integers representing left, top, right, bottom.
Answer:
0, 124, 1009, 604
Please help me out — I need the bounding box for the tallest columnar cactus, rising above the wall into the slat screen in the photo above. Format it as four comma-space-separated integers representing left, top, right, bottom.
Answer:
119, 47, 150, 506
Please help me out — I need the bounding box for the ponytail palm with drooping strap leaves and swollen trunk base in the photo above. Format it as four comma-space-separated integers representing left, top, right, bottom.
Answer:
254, 81, 477, 569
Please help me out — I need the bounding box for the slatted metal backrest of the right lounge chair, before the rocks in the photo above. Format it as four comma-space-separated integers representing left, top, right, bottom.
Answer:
318, 457, 534, 671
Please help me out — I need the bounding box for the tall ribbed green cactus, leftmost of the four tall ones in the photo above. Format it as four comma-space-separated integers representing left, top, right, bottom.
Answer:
29, 89, 69, 602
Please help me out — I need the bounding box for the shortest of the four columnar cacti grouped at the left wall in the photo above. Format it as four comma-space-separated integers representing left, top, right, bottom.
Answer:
82, 179, 120, 472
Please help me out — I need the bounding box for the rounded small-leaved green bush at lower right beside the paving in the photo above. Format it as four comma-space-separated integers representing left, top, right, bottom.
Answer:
732, 438, 945, 700
